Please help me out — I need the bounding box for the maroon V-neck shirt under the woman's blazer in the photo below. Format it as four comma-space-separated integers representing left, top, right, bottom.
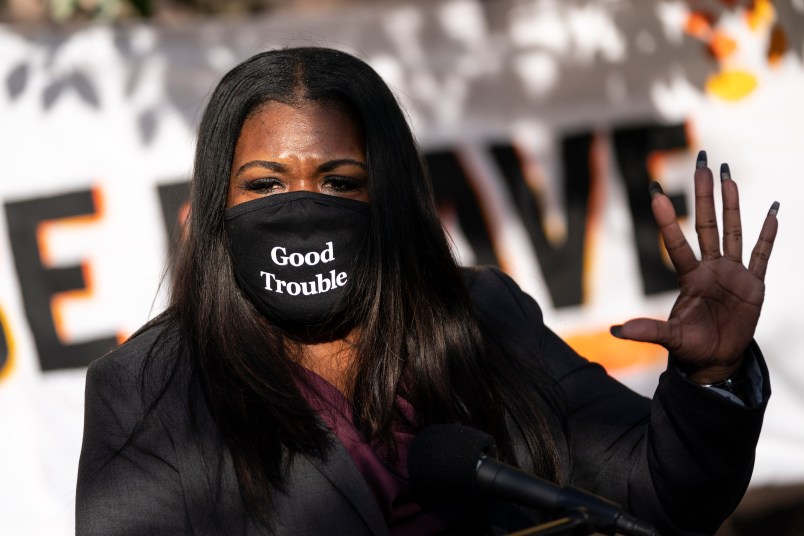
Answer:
297, 367, 483, 536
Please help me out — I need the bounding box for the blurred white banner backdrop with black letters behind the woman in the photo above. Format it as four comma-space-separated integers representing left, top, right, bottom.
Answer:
0, 0, 804, 536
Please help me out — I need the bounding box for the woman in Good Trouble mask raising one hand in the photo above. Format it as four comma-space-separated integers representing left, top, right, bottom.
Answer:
77, 48, 778, 534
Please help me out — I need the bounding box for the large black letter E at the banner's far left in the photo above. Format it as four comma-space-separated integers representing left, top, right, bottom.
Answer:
6, 190, 117, 370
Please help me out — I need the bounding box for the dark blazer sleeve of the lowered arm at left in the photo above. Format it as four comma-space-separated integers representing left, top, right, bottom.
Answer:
76, 347, 190, 536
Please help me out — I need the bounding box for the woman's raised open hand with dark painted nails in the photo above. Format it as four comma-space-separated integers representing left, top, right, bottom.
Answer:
612, 151, 779, 384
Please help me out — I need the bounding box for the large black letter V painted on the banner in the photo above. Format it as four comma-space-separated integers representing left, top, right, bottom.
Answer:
491, 133, 592, 307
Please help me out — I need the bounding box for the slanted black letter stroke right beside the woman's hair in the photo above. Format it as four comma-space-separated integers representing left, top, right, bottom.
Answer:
425, 151, 499, 265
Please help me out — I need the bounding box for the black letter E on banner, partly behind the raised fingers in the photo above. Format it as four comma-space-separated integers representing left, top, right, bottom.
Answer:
613, 125, 692, 295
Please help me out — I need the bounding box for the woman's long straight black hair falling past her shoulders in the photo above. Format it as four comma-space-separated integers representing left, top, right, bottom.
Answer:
140, 48, 561, 519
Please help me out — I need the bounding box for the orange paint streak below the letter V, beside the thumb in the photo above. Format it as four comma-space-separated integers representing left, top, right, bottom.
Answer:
563, 330, 667, 372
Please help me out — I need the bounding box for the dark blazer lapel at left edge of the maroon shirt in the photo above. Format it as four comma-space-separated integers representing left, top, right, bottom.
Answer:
305, 438, 388, 535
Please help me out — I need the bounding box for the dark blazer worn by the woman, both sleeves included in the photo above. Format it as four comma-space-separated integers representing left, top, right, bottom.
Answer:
76, 269, 770, 536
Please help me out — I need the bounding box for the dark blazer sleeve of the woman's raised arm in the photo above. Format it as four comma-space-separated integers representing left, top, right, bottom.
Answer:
470, 269, 770, 535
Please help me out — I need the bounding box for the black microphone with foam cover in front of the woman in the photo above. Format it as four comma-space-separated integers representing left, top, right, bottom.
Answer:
408, 424, 658, 536
